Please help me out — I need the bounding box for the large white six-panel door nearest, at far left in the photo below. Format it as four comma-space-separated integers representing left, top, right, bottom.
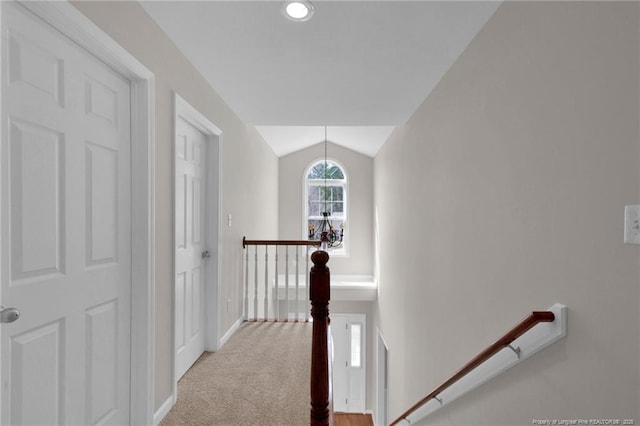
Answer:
0, 2, 131, 425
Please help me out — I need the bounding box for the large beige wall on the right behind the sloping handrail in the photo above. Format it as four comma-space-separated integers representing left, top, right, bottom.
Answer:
374, 2, 640, 425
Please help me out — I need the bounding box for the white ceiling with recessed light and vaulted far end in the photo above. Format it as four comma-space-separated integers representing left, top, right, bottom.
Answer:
142, 0, 500, 157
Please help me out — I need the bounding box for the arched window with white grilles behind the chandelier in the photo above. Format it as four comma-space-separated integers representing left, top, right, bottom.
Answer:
305, 159, 347, 254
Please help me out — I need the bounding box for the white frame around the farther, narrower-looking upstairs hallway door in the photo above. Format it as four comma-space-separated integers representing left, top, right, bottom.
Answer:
172, 92, 222, 394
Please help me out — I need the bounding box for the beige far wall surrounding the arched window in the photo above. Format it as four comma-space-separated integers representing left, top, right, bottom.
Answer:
278, 143, 373, 275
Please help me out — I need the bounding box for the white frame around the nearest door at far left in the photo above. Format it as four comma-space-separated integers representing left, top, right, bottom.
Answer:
0, 2, 155, 424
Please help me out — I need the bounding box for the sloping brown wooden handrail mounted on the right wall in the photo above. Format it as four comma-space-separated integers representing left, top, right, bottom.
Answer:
390, 311, 555, 426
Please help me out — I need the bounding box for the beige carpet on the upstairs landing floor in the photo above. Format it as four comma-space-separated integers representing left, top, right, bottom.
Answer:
160, 322, 312, 426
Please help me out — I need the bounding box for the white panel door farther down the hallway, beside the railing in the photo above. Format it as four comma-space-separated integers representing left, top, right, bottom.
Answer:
175, 118, 207, 379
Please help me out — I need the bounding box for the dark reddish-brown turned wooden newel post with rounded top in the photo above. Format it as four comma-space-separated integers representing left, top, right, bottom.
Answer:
309, 250, 331, 426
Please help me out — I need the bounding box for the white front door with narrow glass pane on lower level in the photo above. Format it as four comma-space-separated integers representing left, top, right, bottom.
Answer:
331, 314, 366, 413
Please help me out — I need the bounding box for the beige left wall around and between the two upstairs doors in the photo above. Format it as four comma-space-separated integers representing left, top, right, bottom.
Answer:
74, 1, 278, 409
